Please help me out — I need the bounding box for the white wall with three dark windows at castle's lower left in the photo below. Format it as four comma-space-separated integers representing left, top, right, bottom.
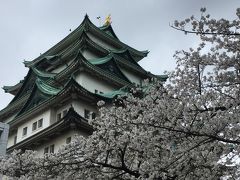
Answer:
17, 109, 51, 143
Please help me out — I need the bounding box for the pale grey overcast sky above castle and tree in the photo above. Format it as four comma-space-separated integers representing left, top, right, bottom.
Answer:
0, 0, 240, 109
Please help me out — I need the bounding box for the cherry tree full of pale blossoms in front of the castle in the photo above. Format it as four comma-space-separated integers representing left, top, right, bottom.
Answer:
0, 8, 240, 180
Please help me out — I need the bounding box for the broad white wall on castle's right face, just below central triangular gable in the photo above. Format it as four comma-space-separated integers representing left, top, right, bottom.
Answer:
76, 72, 116, 93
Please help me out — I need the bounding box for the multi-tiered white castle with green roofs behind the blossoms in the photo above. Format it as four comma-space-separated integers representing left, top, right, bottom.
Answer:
0, 15, 166, 154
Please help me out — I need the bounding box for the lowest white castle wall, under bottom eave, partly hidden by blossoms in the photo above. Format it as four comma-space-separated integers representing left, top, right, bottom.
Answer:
34, 130, 87, 156
